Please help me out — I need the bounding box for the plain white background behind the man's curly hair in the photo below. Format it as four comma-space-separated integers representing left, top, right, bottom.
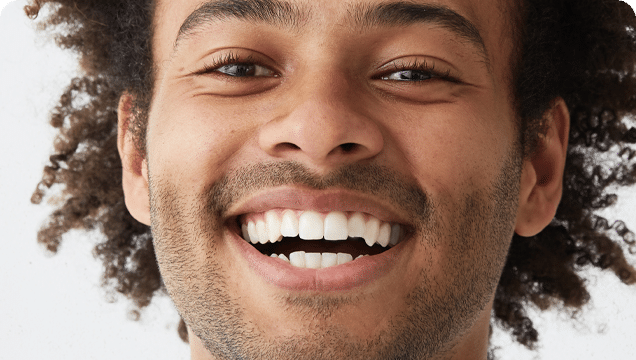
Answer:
0, 0, 636, 360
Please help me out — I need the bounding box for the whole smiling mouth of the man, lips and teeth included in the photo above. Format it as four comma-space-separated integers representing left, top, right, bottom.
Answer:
228, 188, 413, 291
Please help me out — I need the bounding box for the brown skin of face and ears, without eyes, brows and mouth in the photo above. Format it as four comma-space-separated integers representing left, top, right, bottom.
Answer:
118, 0, 569, 360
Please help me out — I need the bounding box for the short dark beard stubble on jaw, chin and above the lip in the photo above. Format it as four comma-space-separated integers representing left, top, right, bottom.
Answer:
149, 154, 521, 360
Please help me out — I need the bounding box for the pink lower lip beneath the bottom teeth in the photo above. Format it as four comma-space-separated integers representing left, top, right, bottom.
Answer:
231, 232, 405, 291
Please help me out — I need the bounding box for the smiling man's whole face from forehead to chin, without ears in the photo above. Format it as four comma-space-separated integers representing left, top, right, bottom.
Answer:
147, 0, 521, 359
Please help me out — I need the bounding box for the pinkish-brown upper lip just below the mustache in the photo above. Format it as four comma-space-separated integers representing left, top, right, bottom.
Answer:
227, 186, 408, 225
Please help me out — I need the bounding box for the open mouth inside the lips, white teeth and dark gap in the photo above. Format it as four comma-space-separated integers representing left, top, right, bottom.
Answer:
236, 209, 407, 269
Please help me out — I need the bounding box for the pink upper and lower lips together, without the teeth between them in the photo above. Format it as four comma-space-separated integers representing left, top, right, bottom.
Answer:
226, 186, 411, 291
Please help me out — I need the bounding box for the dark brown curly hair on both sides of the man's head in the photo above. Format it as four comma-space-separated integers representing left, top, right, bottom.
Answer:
25, 0, 636, 349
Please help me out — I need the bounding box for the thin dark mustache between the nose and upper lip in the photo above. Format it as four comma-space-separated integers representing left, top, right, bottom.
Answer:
205, 161, 432, 223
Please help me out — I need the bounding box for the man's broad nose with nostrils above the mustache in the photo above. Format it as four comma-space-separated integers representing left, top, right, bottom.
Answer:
259, 75, 384, 171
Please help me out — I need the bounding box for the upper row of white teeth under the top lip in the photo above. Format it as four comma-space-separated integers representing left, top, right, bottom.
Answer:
241, 210, 401, 247
